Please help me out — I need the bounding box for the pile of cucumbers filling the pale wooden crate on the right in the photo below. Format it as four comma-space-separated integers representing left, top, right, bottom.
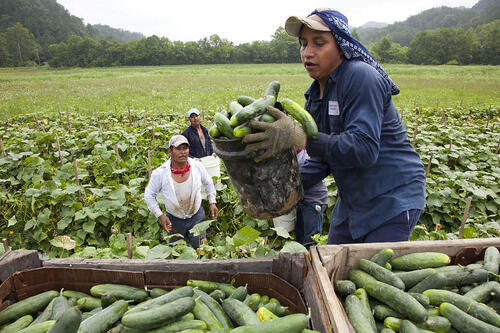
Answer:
334, 247, 500, 333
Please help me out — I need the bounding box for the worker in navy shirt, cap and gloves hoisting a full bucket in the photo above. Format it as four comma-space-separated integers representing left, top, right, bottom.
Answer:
243, 9, 425, 244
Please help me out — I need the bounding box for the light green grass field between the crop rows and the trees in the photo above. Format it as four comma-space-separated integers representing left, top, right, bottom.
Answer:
0, 64, 500, 119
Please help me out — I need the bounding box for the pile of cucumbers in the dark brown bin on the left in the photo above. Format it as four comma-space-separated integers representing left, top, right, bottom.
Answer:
0, 280, 319, 333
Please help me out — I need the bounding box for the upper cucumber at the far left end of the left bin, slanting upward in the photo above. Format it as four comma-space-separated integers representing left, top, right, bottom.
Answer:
0, 290, 59, 325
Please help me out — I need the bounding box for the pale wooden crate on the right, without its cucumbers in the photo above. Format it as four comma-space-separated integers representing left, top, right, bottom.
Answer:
311, 238, 500, 333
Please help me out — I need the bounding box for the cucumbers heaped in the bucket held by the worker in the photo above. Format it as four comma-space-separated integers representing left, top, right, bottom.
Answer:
209, 81, 318, 139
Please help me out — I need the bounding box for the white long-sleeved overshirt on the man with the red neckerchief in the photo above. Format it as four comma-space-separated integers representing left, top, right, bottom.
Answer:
144, 158, 216, 219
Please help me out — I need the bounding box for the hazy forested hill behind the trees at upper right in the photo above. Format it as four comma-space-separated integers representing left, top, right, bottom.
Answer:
356, 0, 500, 46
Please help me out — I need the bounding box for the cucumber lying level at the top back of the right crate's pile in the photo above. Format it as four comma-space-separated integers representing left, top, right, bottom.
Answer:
390, 252, 451, 271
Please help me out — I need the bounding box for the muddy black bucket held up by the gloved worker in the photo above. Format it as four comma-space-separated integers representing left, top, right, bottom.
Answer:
213, 138, 304, 219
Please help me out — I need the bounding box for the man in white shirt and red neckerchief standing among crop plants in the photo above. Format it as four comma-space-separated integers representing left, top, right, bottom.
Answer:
144, 135, 219, 248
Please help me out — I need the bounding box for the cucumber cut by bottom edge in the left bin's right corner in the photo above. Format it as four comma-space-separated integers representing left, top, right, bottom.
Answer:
231, 312, 308, 333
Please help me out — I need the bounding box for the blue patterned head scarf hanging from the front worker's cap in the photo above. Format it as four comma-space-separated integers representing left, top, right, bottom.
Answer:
309, 9, 399, 95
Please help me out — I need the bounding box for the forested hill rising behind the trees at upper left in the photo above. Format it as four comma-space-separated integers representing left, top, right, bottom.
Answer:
0, 0, 144, 54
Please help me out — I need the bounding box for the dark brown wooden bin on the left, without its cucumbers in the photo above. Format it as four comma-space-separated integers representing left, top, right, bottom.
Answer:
0, 251, 332, 332
